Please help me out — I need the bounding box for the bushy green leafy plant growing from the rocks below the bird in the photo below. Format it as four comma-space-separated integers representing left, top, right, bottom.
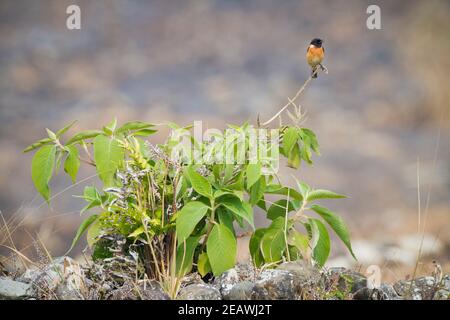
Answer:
24, 72, 354, 296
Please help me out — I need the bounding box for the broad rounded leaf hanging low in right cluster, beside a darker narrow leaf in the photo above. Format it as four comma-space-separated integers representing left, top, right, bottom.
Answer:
260, 217, 289, 262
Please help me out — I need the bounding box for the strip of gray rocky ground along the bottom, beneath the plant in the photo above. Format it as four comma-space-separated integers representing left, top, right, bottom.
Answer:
0, 257, 450, 300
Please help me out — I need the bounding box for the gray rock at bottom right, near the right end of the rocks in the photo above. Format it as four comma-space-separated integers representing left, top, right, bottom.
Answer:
394, 277, 438, 300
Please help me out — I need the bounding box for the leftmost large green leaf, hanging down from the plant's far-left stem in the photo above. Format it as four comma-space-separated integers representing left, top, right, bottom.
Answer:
31, 145, 56, 203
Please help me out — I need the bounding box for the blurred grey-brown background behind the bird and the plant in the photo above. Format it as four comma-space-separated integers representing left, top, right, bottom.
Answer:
0, 0, 450, 280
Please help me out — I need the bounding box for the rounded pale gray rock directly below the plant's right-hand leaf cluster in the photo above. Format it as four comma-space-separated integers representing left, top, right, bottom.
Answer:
252, 269, 299, 300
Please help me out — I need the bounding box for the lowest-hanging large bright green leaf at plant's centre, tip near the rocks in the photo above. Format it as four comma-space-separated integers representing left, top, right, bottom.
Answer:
206, 224, 237, 276
